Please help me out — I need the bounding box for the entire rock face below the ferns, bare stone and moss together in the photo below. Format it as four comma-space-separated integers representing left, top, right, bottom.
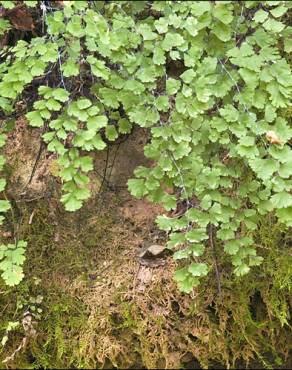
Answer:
0, 120, 292, 369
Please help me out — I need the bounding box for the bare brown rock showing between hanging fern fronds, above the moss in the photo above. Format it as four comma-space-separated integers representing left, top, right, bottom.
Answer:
5, 117, 151, 198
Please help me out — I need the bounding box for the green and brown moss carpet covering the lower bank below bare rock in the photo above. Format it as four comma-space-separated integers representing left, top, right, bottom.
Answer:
0, 198, 292, 368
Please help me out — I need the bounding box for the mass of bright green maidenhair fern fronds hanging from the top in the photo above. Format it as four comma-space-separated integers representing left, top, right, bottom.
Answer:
0, 1, 292, 292
